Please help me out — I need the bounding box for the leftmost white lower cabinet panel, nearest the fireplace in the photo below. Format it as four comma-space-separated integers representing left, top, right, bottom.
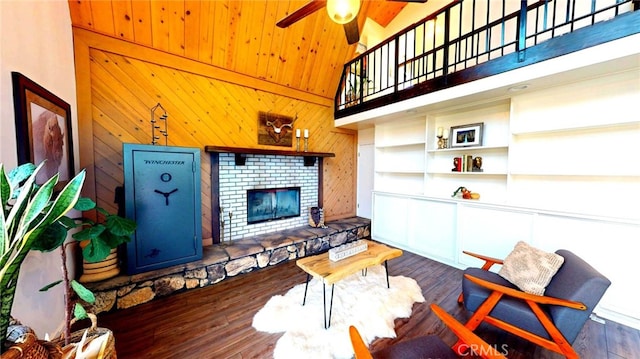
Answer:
371, 193, 408, 246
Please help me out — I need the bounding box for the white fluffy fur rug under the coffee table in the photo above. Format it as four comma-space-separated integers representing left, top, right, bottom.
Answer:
253, 266, 424, 359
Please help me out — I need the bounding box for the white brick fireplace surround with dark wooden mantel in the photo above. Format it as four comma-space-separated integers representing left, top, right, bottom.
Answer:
205, 146, 335, 243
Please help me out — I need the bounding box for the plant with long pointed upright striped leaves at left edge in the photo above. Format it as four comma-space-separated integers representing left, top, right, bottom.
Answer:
0, 163, 85, 351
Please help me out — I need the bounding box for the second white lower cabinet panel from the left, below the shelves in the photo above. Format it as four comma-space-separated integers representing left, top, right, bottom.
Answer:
407, 198, 457, 264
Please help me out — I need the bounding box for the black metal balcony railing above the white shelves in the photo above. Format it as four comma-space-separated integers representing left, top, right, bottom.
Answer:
335, 0, 640, 118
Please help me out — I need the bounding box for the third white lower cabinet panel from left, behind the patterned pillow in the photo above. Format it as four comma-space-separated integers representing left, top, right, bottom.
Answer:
458, 204, 533, 271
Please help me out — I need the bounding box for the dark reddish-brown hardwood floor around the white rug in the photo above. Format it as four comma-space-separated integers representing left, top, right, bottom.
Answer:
99, 252, 640, 359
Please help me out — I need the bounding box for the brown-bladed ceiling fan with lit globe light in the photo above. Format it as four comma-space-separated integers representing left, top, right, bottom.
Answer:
276, 0, 427, 45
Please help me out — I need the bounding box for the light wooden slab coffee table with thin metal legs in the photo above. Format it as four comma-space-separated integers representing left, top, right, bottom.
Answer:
296, 240, 402, 329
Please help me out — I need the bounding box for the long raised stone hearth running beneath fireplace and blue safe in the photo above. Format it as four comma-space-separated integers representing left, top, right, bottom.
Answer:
86, 217, 371, 314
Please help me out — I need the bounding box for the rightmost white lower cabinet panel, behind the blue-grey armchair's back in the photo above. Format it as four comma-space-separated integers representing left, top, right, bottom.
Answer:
533, 215, 640, 328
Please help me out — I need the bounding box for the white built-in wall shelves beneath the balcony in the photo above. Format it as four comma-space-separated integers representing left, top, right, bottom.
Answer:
374, 78, 640, 217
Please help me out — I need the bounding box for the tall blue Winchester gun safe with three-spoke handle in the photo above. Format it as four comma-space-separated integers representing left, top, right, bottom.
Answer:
123, 143, 202, 274
